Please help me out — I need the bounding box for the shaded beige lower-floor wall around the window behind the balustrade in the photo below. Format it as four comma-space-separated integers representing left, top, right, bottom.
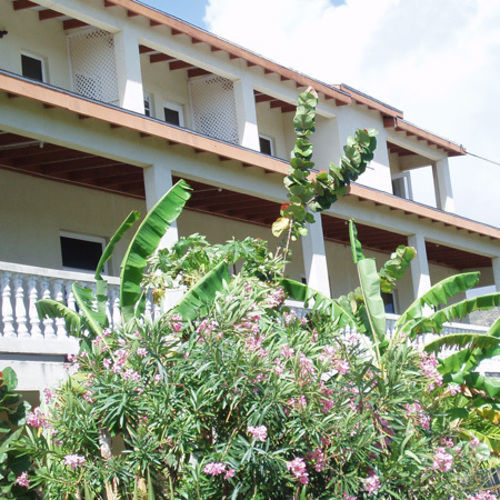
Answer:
0, 170, 146, 275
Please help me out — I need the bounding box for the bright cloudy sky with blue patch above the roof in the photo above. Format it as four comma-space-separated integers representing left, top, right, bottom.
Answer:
145, 0, 500, 226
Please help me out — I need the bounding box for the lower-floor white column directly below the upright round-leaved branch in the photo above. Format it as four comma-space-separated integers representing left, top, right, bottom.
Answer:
302, 214, 331, 297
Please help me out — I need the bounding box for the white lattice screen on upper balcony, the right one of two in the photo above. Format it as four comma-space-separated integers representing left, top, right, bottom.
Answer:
189, 76, 238, 144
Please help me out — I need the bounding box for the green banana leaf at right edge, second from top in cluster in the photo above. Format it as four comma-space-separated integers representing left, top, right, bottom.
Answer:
411, 292, 500, 336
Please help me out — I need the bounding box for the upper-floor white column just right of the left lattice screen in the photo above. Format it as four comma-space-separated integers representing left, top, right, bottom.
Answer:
114, 30, 144, 113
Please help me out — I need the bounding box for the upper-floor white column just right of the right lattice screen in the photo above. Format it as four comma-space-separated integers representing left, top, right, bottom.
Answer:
234, 79, 260, 151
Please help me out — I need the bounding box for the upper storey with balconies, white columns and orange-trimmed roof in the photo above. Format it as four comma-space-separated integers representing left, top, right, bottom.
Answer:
0, 0, 461, 212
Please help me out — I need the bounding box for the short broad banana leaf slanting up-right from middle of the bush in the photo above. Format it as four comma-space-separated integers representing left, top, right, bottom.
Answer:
174, 261, 229, 321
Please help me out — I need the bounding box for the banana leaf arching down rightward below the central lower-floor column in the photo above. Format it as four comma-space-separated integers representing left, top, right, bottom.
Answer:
281, 278, 356, 328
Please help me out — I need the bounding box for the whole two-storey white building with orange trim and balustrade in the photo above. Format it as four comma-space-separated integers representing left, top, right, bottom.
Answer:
0, 0, 500, 398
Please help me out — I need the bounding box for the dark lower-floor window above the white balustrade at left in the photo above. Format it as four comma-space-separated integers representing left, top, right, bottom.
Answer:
60, 232, 107, 272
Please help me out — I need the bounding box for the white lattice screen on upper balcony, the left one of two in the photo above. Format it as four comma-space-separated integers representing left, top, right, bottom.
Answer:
68, 29, 119, 104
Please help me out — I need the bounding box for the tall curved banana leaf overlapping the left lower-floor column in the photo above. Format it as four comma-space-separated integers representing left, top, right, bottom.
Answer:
120, 180, 191, 323
